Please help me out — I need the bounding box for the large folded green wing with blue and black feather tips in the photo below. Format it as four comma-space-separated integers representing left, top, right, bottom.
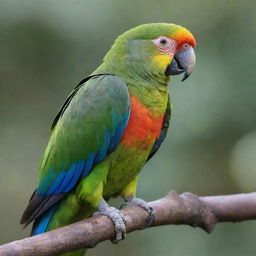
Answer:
21, 74, 130, 225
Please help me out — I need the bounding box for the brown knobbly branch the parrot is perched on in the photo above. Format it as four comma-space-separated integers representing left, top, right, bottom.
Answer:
0, 191, 256, 256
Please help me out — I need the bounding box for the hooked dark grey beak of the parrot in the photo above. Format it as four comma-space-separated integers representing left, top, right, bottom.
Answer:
165, 47, 196, 82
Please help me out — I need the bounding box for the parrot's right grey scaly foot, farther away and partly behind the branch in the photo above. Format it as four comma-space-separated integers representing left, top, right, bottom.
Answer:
121, 197, 156, 227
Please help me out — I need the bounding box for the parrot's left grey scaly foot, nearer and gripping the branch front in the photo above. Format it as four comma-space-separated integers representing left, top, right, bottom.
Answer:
93, 198, 126, 244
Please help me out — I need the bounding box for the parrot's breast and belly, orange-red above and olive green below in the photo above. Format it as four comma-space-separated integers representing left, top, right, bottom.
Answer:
103, 96, 164, 198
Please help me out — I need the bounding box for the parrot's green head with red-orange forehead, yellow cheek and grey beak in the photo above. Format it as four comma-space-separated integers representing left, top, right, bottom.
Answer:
104, 23, 196, 81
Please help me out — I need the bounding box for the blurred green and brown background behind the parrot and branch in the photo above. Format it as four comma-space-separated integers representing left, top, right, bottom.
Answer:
0, 0, 256, 256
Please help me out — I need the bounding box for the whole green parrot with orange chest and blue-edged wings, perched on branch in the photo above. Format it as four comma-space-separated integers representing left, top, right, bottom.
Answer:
20, 23, 196, 256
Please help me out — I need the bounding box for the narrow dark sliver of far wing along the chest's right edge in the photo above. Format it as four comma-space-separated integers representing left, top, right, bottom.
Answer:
147, 97, 171, 161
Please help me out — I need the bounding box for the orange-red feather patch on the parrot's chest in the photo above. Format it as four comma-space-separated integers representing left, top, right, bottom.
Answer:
121, 96, 163, 147
